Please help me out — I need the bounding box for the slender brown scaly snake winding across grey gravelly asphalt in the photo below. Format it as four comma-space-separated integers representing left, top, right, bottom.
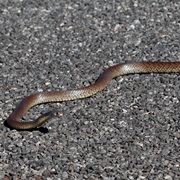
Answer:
7, 62, 180, 130
